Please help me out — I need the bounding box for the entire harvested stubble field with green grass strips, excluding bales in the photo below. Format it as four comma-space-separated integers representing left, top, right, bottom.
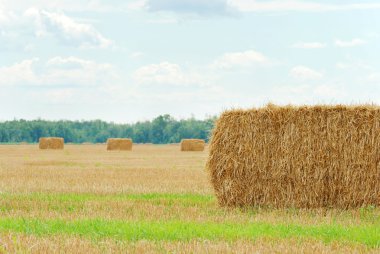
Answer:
0, 145, 380, 253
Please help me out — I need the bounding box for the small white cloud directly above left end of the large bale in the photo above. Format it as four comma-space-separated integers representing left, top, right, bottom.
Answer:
211, 50, 271, 69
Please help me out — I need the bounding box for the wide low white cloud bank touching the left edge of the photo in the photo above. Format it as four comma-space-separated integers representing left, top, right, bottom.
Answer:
0, 57, 117, 87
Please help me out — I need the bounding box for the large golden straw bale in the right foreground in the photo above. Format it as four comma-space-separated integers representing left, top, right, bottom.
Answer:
207, 105, 380, 208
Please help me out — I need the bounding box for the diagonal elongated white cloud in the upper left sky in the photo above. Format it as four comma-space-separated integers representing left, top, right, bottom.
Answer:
25, 8, 112, 48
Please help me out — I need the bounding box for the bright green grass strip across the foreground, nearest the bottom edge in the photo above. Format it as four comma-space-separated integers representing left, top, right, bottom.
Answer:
0, 218, 380, 248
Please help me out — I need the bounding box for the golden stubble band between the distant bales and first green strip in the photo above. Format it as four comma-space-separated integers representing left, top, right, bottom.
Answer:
0, 145, 213, 194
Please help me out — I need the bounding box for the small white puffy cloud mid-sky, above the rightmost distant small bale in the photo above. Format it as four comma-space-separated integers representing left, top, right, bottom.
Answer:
134, 62, 200, 86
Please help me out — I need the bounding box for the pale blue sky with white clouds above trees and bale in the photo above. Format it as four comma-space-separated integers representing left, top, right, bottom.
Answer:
0, 0, 380, 123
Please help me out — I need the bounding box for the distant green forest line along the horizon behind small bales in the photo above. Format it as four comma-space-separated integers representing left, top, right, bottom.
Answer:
0, 115, 216, 144
